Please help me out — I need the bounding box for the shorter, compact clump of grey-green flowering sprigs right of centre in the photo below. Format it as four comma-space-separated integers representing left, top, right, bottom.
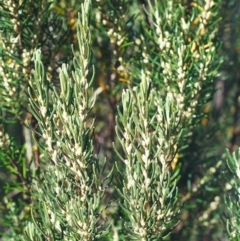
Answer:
117, 72, 181, 240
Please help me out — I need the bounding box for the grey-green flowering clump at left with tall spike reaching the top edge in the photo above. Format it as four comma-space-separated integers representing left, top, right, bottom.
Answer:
20, 1, 110, 240
